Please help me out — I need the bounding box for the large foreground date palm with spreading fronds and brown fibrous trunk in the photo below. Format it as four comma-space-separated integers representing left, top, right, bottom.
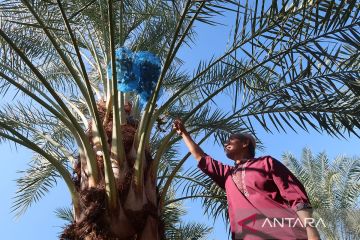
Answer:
0, 0, 360, 239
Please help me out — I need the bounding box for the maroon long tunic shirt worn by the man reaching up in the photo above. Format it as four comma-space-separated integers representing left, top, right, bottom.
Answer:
198, 156, 311, 240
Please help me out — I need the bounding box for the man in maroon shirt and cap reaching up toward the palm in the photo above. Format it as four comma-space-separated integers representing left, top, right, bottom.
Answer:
173, 120, 320, 240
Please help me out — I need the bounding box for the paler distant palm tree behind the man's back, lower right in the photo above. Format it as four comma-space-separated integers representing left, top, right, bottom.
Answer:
283, 149, 360, 239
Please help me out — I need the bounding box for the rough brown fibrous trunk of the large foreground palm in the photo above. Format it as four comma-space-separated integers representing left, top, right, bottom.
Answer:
60, 101, 163, 240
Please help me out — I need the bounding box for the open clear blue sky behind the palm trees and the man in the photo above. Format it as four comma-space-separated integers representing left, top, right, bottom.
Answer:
0, 3, 360, 240
